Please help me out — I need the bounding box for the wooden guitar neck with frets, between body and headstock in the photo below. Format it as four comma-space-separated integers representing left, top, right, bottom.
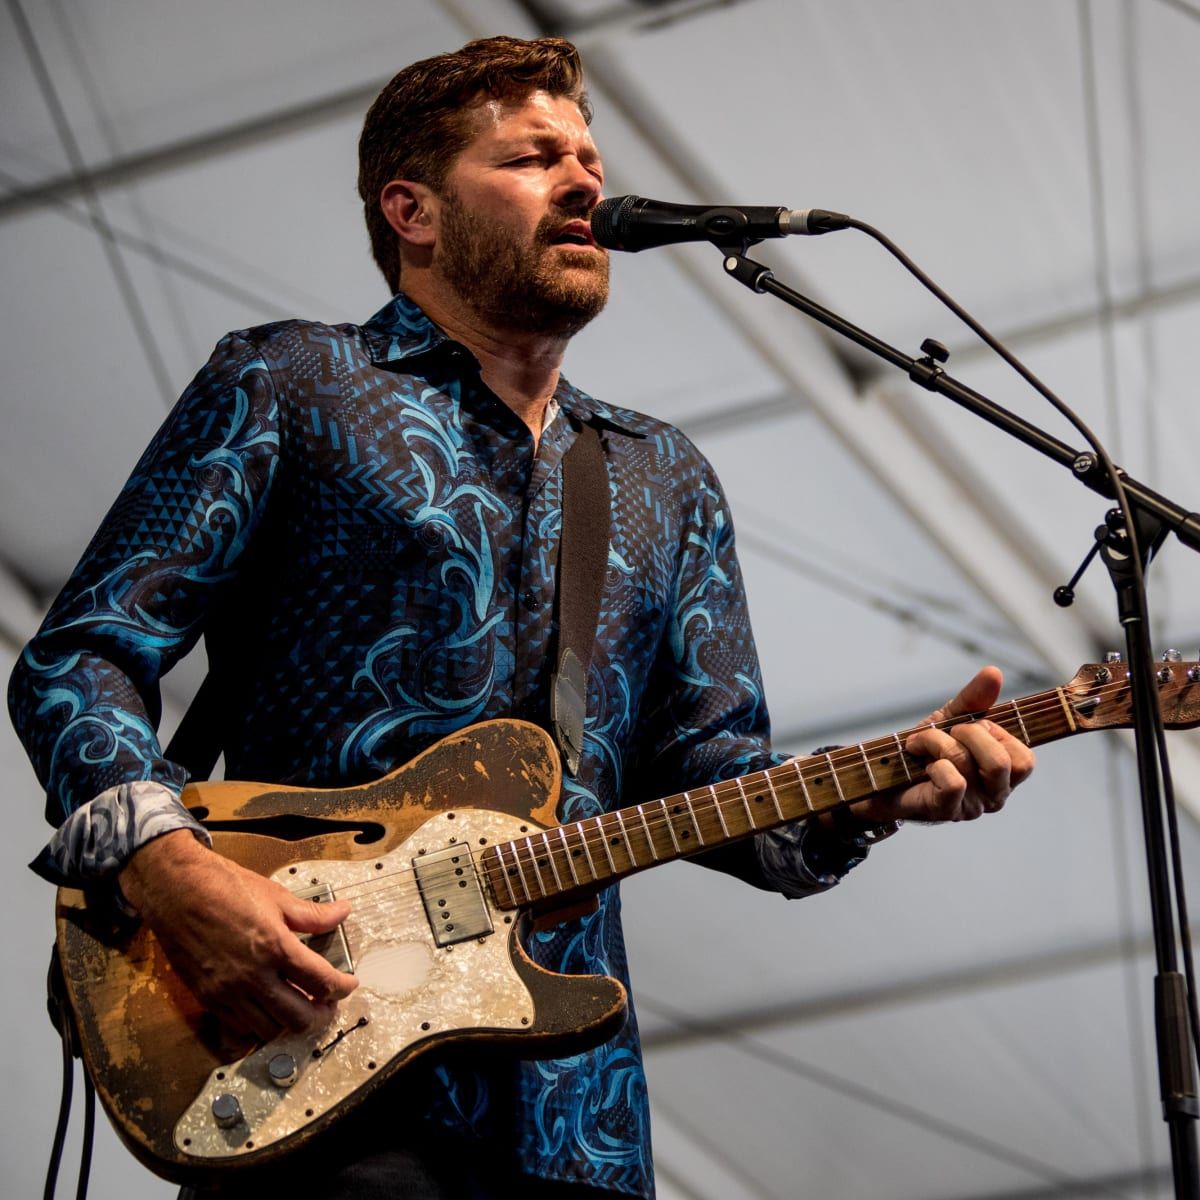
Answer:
480, 688, 1090, 908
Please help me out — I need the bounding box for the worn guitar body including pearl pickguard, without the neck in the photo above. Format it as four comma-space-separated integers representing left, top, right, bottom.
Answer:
56, 721, 626, 1182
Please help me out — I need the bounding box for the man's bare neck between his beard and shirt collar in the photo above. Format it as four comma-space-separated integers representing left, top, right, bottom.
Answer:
404, 271, 569, 446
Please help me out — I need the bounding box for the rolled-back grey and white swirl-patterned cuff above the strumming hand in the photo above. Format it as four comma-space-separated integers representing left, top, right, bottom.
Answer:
29, 780, 212, 887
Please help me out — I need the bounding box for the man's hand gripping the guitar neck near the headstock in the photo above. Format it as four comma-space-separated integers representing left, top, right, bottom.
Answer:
851, 667, 1033, 823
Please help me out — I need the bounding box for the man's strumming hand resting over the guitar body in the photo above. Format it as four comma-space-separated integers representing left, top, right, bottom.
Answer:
119, 829, 358, 1040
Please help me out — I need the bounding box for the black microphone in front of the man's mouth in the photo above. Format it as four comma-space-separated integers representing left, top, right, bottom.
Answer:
592, 196, 851, 251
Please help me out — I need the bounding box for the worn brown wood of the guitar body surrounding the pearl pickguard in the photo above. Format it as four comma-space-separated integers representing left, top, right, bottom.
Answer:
58, 721, 625, 1182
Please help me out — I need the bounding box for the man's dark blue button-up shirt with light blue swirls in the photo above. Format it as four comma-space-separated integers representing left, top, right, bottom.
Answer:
10, 296, 847, 1195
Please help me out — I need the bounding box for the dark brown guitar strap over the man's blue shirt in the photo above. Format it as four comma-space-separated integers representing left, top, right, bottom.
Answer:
164, 424, 611, 779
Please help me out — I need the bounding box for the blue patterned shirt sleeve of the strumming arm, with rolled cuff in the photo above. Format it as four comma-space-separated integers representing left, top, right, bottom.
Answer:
8, 334, 280, 882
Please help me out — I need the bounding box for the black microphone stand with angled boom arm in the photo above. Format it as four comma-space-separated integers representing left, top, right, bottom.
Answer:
718, 240, 1200, 1200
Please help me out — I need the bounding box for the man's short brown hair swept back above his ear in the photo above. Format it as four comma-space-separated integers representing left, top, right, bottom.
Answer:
359, 37, 592, 292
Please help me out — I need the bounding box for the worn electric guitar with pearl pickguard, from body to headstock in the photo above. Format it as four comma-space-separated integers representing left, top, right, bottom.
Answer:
49, 662, 1200, 1183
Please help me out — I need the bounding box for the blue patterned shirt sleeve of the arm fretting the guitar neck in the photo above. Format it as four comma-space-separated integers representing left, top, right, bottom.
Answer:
638, 451, 866, 899
